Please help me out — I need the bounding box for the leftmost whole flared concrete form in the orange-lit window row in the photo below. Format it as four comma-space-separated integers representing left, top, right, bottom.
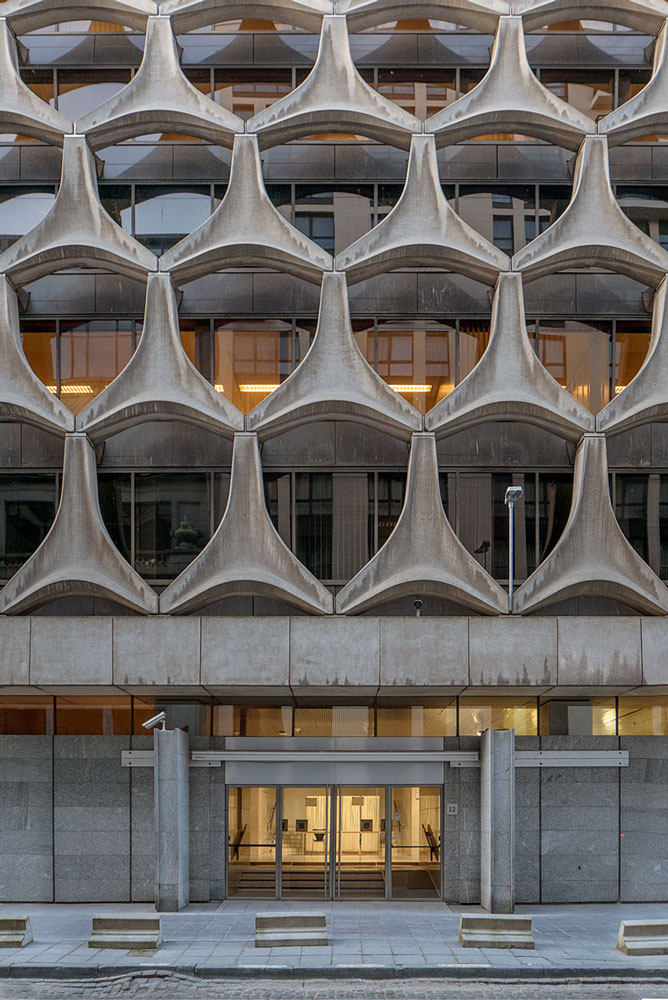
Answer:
77, 274, 244, 441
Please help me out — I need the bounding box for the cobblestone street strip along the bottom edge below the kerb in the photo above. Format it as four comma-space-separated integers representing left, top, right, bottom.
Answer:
0, 973, 668, 1000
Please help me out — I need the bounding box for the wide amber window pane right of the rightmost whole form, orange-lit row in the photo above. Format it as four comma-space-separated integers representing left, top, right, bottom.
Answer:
538, 320, 611, 413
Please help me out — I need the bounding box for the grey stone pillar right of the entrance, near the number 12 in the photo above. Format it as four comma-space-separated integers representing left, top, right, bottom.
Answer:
480, 729, 515, 913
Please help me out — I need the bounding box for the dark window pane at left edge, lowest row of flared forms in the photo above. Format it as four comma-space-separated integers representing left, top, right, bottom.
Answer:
0, 474, 57, 580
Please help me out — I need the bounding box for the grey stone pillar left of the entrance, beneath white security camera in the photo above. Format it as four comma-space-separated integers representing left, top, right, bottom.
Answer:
153, 729, 190, 912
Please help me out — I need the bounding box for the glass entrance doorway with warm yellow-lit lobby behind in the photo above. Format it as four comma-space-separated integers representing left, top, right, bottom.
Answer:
227, 785, 441, 899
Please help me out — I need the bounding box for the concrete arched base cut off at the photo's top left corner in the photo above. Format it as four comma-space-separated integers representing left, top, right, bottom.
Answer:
2, 0, 158, 35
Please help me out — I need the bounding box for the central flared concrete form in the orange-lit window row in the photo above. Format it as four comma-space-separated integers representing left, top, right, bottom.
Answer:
246, 273, 422, 438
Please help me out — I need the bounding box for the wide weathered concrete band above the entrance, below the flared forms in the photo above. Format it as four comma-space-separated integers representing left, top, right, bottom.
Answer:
0, 616, 668, 698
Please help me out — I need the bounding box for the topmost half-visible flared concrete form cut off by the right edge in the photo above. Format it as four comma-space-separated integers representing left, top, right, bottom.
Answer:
598, 21, 668, 146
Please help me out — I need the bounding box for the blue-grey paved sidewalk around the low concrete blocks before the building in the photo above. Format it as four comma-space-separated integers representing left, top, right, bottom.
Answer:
0, 900, 668, 980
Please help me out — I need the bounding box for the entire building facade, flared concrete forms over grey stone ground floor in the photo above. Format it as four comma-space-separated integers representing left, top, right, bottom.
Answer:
0, 0, 668, 912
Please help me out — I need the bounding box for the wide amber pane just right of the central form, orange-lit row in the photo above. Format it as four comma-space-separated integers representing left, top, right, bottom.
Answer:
377, 321, 456, 413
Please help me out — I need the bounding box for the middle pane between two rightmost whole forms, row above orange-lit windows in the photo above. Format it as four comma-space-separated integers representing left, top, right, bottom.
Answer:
458, 184, 536, 254
